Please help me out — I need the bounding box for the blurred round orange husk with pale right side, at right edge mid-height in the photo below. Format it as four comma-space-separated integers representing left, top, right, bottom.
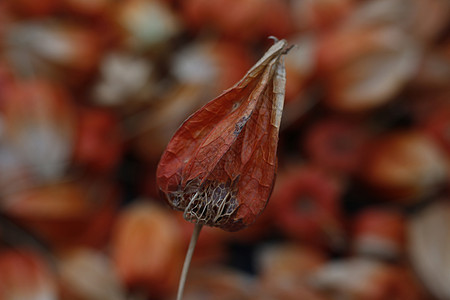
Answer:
360, 130, 449, 204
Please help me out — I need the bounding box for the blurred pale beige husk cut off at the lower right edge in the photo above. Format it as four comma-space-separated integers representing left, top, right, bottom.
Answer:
408, 201, 450, 299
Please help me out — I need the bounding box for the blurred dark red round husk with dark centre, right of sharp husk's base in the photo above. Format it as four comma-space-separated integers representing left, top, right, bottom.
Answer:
271, 166, 342, 247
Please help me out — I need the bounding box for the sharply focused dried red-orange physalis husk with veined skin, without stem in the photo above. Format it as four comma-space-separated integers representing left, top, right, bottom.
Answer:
157, 40, 287, 231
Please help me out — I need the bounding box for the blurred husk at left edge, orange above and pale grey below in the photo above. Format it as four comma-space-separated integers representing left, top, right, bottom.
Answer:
0, 79, 75, 180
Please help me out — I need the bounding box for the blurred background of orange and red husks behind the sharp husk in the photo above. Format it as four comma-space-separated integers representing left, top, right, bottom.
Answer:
0, 0, 450, 300
